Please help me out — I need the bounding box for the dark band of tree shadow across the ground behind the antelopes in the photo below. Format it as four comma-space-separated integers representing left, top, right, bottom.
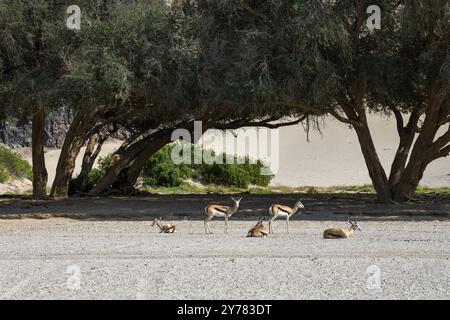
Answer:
0, 194, 450, 221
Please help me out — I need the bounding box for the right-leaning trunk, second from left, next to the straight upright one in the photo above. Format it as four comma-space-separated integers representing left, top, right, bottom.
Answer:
50, 111, 92, 199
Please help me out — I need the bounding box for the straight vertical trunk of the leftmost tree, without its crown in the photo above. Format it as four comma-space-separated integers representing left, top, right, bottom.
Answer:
32, 111, 48, 200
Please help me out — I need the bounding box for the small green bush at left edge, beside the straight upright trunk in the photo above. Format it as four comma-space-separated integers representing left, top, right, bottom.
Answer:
0, 147, 32, 182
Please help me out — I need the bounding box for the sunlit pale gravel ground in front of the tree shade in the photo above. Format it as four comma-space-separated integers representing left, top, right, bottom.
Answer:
0, 217, 450, 300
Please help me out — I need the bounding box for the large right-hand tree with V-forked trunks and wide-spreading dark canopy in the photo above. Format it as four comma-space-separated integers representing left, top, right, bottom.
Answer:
196, 0, 450, 202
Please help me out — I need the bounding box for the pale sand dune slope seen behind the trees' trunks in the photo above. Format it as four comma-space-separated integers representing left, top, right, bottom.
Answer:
206, 116, 450, 187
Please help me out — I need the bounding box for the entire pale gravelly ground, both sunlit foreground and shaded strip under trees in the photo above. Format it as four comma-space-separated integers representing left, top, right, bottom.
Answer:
0, 194, 450, 300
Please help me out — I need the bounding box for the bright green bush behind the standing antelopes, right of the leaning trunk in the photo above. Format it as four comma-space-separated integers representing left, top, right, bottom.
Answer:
143, 145, 273, 189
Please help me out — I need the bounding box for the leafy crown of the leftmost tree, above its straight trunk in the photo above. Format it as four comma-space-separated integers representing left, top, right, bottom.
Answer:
0, 0, 70, 114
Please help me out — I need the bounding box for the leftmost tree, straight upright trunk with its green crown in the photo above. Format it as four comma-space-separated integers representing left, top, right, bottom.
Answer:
0, 0, 69, 200
